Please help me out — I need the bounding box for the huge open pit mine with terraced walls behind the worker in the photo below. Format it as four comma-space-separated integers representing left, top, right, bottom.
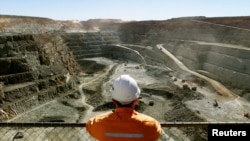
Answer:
0, 15, 250, 140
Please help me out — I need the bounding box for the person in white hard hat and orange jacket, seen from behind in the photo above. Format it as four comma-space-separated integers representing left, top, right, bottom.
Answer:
86, 74, 162, 141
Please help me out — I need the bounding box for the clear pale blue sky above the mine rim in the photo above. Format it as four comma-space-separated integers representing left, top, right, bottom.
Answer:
0, 0, 250, 20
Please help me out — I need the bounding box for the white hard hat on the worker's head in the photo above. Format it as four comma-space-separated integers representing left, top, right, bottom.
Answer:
111, 74, 141, 104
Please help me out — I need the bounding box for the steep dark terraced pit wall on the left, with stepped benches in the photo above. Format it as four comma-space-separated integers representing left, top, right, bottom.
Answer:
0, 32, 148, 121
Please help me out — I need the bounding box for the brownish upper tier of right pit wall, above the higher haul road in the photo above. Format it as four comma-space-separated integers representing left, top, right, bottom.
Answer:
117, 19, 250, 47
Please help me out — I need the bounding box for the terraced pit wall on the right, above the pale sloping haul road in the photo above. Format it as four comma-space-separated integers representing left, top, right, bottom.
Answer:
118, 19, 250, 89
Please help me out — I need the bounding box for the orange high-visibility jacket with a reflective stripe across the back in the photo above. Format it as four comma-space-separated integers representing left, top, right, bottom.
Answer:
86, 108, 162, 141
